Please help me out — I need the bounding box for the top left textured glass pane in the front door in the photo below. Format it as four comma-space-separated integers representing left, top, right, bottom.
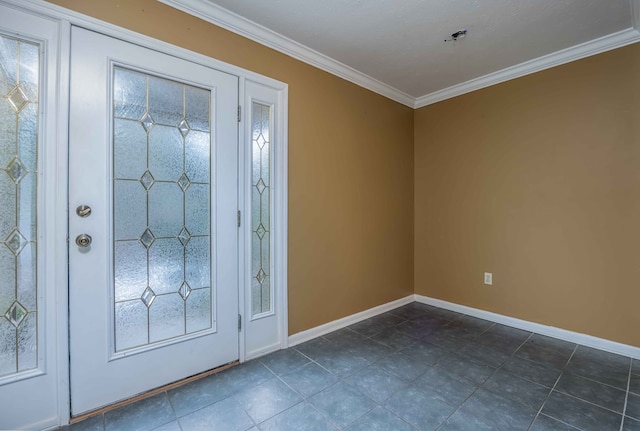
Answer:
113, 68, 147, 120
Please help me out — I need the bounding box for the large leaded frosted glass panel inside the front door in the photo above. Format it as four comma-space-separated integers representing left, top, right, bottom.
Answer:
113, 67, 213, 352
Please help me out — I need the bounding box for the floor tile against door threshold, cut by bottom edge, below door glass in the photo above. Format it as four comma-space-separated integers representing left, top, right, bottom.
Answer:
104, 392, 176, 431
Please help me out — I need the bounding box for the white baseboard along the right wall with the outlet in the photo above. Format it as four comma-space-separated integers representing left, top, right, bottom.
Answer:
414, 295, 640, 359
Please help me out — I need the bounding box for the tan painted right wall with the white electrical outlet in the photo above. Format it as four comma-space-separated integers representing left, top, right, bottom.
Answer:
414, 44, 640, 346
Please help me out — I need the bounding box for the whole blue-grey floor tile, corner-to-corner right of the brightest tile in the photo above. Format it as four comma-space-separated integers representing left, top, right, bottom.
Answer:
309, 382, 376, 428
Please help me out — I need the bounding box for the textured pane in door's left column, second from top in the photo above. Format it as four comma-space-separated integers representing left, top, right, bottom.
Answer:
113, 119, 147, 180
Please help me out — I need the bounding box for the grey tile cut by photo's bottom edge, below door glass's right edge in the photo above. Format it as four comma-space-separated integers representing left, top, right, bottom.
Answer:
178, 398, 255, 431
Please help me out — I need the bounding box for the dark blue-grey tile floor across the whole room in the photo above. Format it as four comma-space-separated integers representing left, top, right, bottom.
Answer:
64, 303, 640, 431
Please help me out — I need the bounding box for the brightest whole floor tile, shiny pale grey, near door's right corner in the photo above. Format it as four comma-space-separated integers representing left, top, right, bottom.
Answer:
233, 379, 302, 424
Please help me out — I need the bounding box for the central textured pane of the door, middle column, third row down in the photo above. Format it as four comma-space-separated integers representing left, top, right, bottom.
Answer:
148, 183, 182, 237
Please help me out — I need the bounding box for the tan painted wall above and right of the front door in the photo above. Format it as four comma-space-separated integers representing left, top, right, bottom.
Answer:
52, 0, 413, 334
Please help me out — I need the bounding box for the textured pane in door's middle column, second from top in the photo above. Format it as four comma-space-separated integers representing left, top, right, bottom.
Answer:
149, 126, 184, 181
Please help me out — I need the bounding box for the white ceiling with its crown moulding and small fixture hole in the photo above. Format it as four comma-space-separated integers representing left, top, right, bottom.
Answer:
161, 0, 640, 106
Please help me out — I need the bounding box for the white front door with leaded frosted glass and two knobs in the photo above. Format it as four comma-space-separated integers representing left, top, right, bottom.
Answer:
69, 28, 239, 415
